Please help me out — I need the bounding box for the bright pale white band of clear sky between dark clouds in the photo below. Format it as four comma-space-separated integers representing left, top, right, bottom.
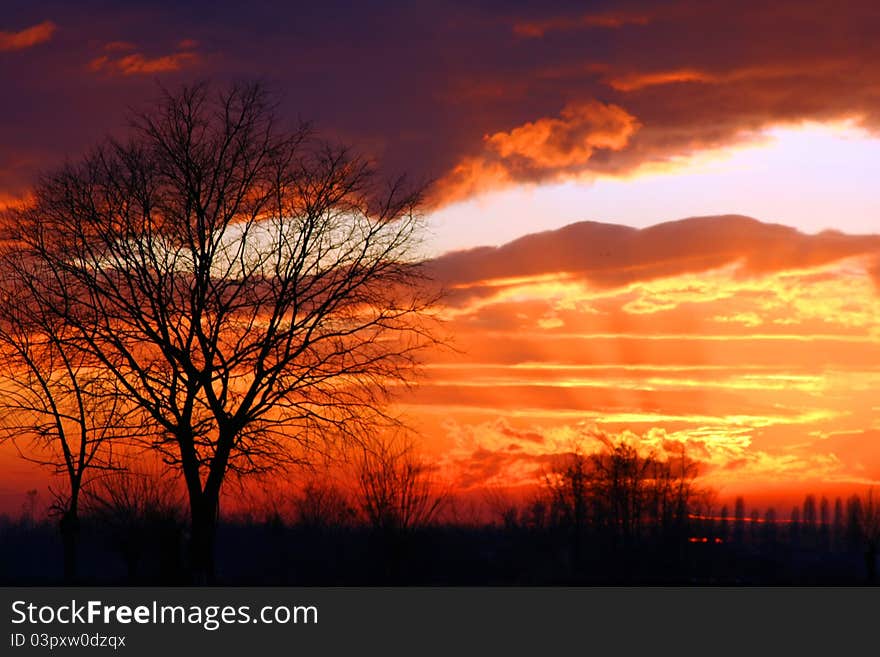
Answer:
430, 117, 880, 253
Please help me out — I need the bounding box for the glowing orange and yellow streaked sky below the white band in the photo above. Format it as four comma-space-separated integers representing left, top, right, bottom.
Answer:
386, 217, 880, 508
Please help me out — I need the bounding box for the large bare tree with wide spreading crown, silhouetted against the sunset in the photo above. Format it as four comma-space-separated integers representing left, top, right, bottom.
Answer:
9, 84, 433, 582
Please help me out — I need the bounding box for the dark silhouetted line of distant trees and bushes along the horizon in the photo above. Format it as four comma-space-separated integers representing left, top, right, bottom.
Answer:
0, 440, 880, 584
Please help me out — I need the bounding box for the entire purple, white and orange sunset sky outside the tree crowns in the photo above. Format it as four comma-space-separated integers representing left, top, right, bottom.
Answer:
0, 0, 880, 510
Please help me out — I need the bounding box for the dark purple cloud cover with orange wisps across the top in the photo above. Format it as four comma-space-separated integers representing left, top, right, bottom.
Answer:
0, 0, 880, 202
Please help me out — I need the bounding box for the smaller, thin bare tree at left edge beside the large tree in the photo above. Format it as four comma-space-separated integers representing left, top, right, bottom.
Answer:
0, 258, 124, 581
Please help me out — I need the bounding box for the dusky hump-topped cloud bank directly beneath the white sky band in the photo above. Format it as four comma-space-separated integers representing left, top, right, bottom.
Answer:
430, 215, 880, 290
